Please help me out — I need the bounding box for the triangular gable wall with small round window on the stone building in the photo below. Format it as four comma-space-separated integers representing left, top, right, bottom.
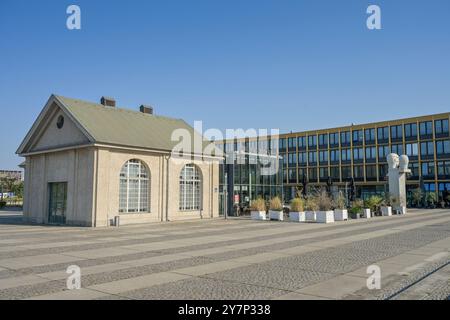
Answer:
17, 95, 94, 154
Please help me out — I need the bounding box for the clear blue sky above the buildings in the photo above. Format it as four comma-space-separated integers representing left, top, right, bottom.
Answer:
0, 0, 450, 169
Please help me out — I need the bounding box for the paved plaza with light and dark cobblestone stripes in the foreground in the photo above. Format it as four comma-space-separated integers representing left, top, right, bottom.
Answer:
0, 210, 450, 300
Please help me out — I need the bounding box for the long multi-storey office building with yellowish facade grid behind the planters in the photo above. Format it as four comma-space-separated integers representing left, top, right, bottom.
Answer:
217, 113, 450, 210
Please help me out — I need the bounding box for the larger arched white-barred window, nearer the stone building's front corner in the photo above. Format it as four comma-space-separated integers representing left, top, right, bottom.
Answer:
119, 160, 150, 213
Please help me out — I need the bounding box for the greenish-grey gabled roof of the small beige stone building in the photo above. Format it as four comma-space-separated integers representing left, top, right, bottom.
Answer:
17, 95, 214, 154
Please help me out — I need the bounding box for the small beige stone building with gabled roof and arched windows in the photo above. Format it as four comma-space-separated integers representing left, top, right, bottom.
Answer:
17, 95, 219, 227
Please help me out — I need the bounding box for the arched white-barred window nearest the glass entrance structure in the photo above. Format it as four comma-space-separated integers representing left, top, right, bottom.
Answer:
180, 164, 202, 211
